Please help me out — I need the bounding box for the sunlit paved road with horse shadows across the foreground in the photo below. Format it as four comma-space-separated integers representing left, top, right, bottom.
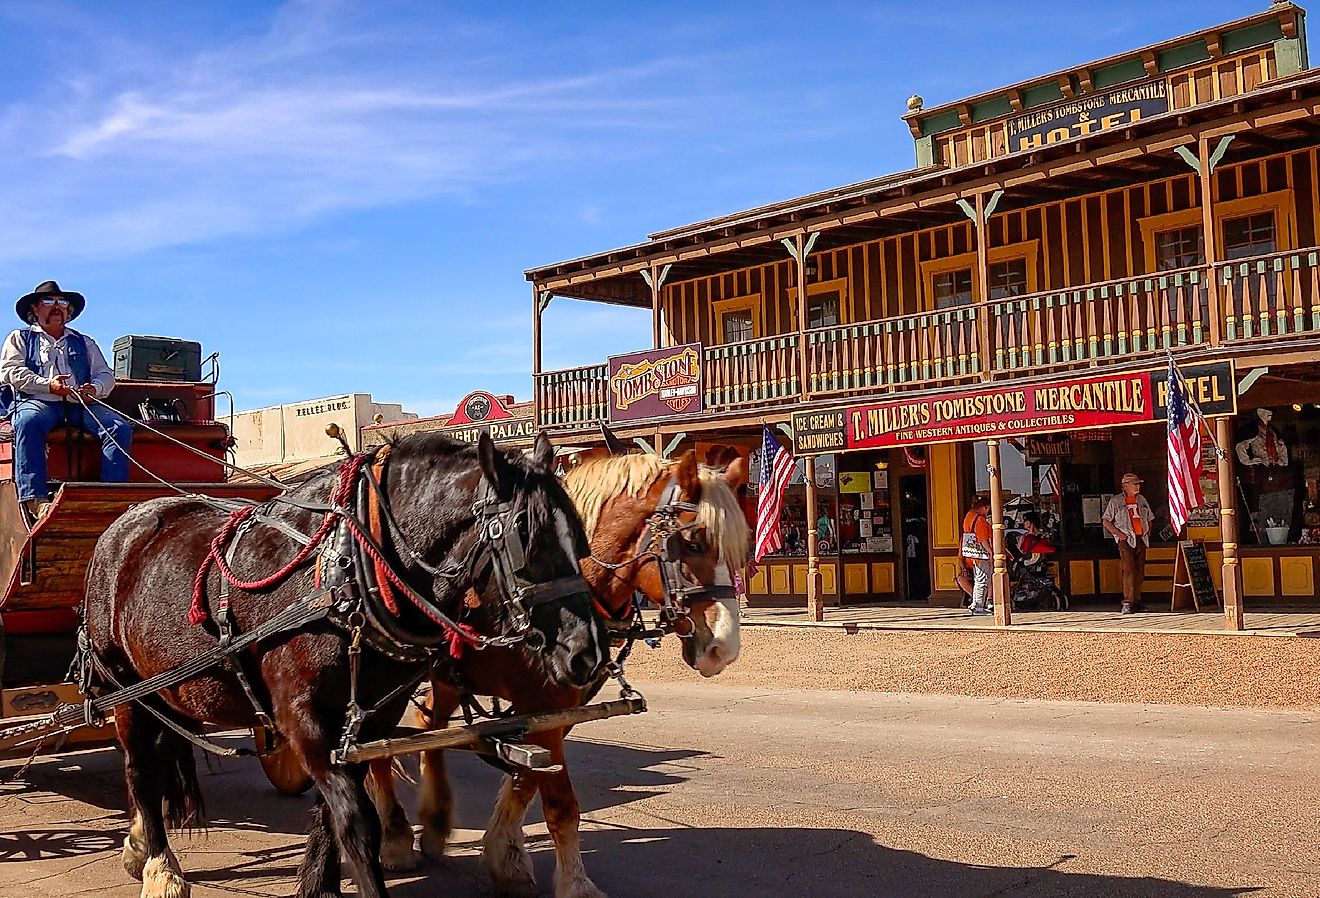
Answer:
0, 671, 1320, 898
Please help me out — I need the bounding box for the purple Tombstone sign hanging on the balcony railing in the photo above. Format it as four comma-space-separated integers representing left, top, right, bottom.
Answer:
610, 343, 702, 421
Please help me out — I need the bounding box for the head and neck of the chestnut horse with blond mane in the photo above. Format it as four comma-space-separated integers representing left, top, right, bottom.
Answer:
565, 452, 750, 676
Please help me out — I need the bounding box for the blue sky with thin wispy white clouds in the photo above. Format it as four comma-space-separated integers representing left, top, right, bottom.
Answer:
0, 0, 1298, 415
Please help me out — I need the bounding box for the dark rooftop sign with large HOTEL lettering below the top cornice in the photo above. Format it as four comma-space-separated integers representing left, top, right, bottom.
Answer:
1008, 81, 1168, 153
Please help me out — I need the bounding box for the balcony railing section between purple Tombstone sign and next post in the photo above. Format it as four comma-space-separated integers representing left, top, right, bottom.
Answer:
704, 334, 801, 408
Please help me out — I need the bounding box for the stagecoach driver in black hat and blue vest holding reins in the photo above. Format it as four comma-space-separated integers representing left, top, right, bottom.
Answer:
0, 281, 133, 520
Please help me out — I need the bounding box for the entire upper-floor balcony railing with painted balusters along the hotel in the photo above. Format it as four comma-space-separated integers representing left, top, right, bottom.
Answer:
536, 247, 1320, 429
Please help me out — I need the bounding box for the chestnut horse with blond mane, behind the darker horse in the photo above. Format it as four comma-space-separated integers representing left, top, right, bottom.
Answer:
372, 452, 750, 898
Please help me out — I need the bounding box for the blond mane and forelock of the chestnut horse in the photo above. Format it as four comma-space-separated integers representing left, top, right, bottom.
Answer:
564, 454, 751, 570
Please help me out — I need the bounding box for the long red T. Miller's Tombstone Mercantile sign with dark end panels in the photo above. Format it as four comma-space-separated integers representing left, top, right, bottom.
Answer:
793, 362, 1237, 456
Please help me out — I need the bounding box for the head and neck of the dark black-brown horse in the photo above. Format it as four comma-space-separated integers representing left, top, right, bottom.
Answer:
387, 433, 606, 687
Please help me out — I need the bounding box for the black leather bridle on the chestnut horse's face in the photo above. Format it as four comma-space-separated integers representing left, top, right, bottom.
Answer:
590, 474, 734, 639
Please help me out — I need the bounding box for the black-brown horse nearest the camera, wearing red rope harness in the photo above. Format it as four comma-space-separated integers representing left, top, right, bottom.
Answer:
77, 434, 606, 898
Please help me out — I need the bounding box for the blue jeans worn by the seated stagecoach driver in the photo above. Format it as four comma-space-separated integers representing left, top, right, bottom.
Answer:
12, 399, 133, 502
